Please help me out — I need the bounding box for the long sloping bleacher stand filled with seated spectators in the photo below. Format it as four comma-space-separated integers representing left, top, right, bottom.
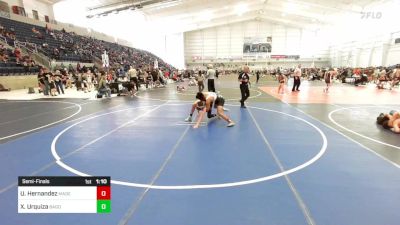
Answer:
0, 17, 175, 74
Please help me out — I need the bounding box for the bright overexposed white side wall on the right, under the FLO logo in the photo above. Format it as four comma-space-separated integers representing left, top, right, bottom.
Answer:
323, 0, 400, 67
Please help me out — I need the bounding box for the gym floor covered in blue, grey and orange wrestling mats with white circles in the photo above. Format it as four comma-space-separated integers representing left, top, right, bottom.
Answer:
0, 75, 400, 225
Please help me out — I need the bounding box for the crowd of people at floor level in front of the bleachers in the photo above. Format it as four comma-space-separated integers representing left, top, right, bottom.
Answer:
38, 63, 178, 96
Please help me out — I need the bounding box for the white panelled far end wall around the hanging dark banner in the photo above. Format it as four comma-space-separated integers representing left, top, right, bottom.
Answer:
184, 21, 329, 65
